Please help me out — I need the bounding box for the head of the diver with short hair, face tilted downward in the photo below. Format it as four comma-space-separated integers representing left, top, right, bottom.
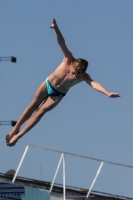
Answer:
73, 58, 89, 75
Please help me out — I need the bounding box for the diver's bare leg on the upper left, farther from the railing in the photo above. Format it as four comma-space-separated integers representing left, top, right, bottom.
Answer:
6, 82, 47, 143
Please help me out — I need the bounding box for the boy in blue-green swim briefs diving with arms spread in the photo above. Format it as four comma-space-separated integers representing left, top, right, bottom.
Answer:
6, 19, 120, 146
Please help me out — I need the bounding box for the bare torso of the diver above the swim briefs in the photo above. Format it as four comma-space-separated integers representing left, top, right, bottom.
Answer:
48, 58, 84, 93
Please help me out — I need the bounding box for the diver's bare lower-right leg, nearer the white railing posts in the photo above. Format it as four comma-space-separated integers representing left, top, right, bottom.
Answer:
8, 96, 63, 146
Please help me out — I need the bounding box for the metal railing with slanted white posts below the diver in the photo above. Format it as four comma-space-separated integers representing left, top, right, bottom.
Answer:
0, 138, 133, 200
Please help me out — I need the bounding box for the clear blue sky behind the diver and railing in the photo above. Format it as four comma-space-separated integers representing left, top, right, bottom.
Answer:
0, 0, 133, 197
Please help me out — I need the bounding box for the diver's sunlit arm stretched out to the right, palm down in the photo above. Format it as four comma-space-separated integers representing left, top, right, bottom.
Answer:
84, 73, 120, 98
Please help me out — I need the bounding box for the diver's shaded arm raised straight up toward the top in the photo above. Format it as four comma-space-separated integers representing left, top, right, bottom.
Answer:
50, 18, 72, 58
